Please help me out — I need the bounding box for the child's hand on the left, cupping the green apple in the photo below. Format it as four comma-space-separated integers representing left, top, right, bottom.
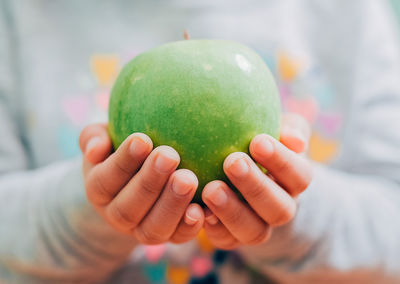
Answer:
79, 124, 204, 244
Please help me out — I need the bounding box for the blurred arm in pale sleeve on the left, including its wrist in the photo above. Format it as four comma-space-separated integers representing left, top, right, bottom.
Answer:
0, 5, 135, 283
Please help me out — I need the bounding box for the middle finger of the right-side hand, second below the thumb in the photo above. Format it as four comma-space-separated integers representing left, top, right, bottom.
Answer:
223, 152, 296, 226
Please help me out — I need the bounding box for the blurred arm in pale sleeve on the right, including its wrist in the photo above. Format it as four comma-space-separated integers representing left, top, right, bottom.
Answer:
241, 0, 400, 283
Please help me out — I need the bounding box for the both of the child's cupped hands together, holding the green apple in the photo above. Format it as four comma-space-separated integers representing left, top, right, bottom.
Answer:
79, 114, 311, 249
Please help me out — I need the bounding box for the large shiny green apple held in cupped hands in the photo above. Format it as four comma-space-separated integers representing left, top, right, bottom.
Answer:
109, 40, 281, 203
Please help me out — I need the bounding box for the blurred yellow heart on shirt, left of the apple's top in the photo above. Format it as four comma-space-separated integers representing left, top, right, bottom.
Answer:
90, 54, 120, 86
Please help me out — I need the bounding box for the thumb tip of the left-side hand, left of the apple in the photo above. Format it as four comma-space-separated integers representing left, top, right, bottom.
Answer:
79, 123, 112, 164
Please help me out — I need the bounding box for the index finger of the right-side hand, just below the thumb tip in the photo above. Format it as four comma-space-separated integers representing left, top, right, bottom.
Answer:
250, 134, 312, 196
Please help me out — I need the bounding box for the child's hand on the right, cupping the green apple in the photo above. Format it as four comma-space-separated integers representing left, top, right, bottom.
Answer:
202, 114, 311, 249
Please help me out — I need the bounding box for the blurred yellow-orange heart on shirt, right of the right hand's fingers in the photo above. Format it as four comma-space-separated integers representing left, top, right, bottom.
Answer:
309, 132, 339, 163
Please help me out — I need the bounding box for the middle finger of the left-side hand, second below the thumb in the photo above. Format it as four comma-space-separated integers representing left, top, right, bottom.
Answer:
106, 146, 179, 231
